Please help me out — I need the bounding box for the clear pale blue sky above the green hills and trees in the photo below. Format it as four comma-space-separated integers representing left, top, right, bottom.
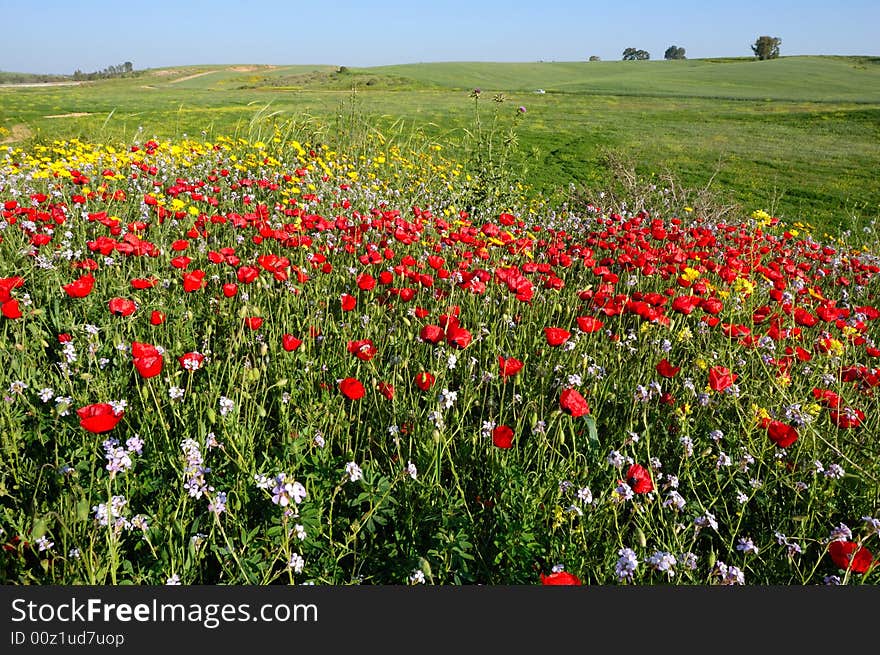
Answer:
0, 0, 880, 73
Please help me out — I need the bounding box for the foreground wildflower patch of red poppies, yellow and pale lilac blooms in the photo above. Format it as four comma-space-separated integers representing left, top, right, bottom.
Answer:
0, 94, 880, 585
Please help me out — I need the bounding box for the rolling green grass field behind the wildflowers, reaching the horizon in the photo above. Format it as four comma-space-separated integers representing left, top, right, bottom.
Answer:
0, 57, 880, 231
